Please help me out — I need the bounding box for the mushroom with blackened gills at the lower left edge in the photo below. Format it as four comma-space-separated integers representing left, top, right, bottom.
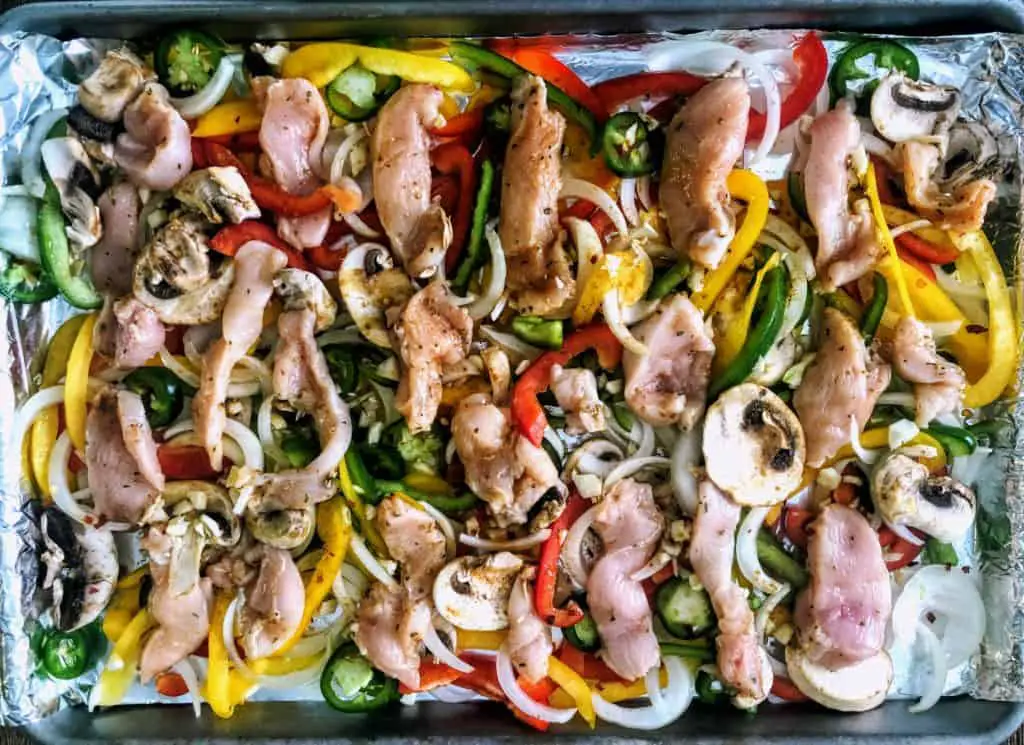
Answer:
40, 509, 118, 631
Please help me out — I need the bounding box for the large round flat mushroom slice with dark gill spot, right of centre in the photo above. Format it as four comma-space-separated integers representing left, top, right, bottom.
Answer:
703, 383, 807, 507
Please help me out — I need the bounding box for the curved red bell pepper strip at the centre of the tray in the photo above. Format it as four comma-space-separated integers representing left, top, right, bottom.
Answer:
512, 323, 623, 447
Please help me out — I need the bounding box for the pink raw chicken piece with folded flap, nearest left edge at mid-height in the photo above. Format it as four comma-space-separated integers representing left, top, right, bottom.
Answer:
85, 389, 163, 525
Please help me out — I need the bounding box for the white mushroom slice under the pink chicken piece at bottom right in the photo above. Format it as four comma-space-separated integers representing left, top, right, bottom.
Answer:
785, 647, 893, 711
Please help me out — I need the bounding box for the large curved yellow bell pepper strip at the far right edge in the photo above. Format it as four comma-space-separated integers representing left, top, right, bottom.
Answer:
952, 230, 1020, 408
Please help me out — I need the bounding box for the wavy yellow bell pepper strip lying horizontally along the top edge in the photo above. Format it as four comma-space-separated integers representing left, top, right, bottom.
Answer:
281, 42, 476, 92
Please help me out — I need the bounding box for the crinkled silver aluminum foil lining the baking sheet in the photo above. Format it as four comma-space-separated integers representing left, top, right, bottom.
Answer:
0, 31, 1024, 725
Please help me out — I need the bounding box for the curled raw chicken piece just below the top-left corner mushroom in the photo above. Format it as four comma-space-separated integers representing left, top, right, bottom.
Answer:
114, 83, 193, 191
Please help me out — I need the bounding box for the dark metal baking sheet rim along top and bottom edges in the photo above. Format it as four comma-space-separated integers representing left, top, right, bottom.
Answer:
0, 0, 1024, 745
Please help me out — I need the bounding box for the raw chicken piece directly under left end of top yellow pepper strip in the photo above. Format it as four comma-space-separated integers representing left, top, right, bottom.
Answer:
259, 78, 331, 194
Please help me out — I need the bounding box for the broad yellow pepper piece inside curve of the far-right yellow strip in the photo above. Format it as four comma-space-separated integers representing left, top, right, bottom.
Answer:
876, 258, 988, 381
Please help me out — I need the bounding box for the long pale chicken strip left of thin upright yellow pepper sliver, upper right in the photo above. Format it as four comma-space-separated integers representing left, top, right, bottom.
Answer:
804, 101, 883, 292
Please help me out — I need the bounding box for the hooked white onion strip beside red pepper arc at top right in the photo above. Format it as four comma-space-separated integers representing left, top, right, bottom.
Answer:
647, 41, 782, 167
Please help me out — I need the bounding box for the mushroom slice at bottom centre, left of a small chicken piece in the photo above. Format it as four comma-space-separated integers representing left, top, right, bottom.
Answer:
434, 551, 522, 631
